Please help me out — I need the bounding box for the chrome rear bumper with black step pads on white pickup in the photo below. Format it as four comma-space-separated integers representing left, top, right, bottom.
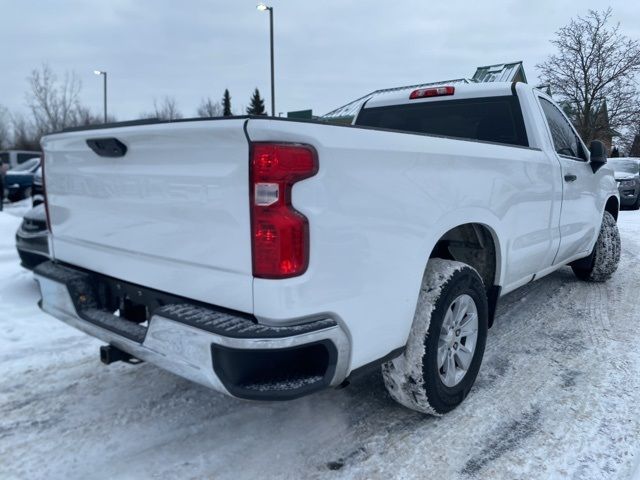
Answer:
34, 262, 349, 400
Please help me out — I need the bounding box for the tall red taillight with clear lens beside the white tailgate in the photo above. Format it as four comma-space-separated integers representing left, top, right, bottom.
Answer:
250, 143, 318, 278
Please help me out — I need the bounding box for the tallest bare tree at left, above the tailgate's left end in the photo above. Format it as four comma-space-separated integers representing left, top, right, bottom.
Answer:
27, 64, 81, 135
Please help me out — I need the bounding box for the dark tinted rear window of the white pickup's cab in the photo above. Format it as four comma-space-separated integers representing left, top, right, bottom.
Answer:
355, 95, 529, 147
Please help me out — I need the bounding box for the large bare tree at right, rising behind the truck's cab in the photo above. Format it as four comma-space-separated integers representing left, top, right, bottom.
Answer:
537, 8, 640, 144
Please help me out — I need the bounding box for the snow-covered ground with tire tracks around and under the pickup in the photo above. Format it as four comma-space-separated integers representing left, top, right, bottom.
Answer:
0, 205, 640, 480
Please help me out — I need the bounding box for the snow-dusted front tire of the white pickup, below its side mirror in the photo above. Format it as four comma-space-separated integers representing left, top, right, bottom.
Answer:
571, 212, 620, 282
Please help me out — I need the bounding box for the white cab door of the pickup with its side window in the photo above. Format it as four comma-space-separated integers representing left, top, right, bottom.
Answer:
538, 95, 602, 265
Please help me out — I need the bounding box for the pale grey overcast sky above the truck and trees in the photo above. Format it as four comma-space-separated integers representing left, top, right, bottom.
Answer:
0, 0, 640, 120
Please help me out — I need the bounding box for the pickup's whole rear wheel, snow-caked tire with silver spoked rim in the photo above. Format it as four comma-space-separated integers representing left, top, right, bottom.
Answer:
382, 258, 489, 415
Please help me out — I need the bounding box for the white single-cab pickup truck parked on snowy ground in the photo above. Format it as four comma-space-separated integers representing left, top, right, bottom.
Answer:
35, 83, 620, 414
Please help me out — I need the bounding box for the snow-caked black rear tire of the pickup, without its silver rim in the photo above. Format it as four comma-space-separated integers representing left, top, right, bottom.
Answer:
382, 258, 489, 415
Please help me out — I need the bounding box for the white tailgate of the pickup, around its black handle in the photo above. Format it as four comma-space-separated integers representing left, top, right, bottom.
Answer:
43, 119, 253, 312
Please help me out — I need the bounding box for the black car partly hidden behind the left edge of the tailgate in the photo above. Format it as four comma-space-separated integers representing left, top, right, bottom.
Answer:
16, 205, 49, 270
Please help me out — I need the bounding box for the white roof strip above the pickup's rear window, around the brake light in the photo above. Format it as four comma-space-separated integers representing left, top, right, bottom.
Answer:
362, 82, 514, 109
